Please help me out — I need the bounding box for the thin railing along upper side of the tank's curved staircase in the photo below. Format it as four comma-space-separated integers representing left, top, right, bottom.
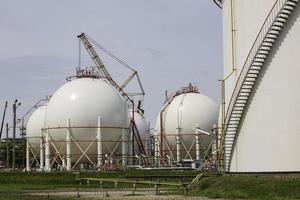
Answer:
225, 0, 288, 167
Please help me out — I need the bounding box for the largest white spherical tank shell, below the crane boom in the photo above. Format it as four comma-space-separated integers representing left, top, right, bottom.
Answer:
46, 78, 130, 162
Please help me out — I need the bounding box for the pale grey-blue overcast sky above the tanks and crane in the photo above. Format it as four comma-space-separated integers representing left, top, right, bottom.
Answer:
0, 0, 222, 136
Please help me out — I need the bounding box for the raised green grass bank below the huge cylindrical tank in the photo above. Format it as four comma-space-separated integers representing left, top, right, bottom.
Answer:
189, 176, 300, 200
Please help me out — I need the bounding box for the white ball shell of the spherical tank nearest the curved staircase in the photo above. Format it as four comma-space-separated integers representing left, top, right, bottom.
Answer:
155, 92, 218, 160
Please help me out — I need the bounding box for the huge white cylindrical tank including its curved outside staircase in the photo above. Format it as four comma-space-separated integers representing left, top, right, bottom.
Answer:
215, 0, 300, 172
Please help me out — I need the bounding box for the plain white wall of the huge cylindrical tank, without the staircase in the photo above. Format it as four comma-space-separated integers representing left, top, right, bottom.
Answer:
222, 0, 300, 172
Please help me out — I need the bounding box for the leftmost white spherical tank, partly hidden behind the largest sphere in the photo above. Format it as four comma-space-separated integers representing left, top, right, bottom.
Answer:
26, 105, 47, 157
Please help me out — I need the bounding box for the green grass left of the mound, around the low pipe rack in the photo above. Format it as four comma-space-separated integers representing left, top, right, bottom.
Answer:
0, 170, 196, 200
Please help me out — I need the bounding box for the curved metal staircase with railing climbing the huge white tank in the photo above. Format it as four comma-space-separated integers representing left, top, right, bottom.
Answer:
220, 0, 298, 172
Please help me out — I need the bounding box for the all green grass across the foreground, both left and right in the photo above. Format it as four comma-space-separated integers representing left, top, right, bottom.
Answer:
0, 170, 300, 200
